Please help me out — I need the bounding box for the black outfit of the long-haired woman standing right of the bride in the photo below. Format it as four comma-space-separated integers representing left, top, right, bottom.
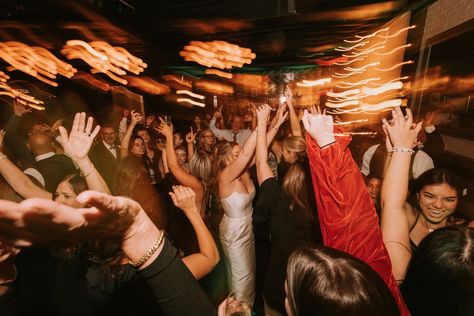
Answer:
253, 177, 321, 314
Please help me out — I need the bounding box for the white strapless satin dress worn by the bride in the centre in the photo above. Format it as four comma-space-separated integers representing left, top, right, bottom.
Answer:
219, 189, 255, 304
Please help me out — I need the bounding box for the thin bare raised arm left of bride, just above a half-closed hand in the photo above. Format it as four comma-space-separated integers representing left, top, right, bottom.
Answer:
156, 118, 204, 209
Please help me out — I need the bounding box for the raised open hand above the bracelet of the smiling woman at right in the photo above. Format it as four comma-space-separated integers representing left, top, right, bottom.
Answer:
382, 107, 422, 149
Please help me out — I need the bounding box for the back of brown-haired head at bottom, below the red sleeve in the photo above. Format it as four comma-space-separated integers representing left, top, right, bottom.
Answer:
285, 247, 400, 316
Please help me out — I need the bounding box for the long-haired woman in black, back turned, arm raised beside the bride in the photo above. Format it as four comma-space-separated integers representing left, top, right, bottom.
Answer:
253, 106, 322, 315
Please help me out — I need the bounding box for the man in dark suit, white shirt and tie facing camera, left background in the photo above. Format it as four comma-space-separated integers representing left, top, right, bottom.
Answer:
90, 124, 120, 188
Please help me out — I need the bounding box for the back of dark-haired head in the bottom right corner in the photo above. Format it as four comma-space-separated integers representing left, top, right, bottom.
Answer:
401, 226, 474, 316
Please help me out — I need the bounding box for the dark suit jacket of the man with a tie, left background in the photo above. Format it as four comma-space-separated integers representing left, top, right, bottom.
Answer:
89, 140, 120, 188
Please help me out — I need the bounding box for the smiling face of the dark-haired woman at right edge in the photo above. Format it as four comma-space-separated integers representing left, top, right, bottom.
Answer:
418, 183, 458, 224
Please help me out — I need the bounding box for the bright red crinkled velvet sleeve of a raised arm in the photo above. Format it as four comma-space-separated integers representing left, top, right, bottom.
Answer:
306, 131, 410, 315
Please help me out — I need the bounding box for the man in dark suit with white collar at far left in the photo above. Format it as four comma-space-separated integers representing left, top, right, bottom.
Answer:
25, 133, 77, 193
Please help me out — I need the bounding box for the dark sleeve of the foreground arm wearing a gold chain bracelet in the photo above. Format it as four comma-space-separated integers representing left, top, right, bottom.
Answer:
138, 239, 217, 316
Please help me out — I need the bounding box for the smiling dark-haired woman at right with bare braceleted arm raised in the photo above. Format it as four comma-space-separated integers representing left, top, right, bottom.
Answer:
381, 108, 474, 281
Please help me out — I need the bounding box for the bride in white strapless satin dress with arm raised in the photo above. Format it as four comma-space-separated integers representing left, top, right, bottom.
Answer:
214, 131, 257, 303
